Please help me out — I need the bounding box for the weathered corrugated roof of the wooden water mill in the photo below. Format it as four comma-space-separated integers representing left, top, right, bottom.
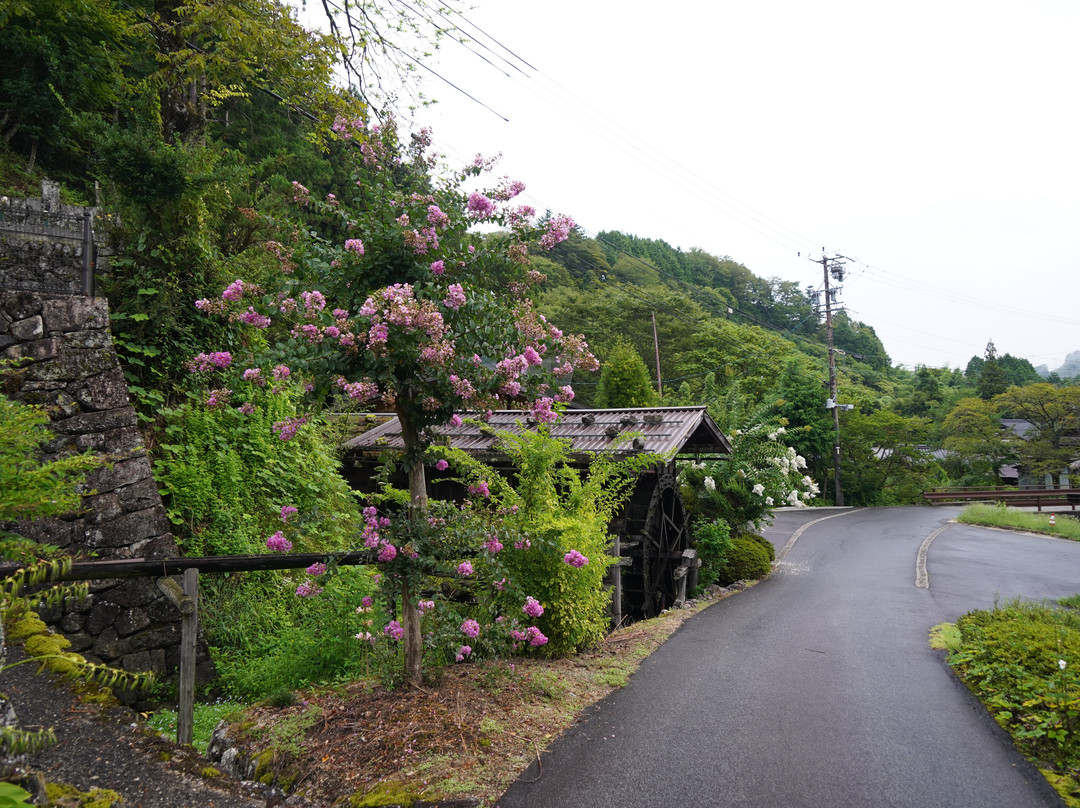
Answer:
345, 407, 731, 455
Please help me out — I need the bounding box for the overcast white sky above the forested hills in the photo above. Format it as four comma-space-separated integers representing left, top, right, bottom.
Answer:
308, 0, 1080, 369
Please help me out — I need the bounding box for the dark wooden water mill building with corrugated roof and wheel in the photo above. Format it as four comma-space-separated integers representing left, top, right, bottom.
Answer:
345, 406, 731, 624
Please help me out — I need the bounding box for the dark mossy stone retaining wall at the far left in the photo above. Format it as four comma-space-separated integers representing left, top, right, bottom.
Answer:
0, 189, 213, 695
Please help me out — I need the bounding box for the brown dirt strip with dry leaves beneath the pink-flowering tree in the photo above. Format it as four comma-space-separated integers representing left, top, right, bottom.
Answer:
214, 606, 721, 805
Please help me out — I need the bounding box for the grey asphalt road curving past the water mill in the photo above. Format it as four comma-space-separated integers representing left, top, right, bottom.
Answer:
498, 508, 1080, 808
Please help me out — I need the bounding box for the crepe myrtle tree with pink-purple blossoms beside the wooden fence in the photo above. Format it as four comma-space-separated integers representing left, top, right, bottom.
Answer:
190, 120, 597, 684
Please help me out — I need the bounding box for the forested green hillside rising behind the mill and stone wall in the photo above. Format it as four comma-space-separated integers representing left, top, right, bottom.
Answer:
0, 0, 1075, 504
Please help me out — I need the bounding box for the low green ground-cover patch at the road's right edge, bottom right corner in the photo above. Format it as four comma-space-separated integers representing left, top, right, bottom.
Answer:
937, 596, 1080, 808
